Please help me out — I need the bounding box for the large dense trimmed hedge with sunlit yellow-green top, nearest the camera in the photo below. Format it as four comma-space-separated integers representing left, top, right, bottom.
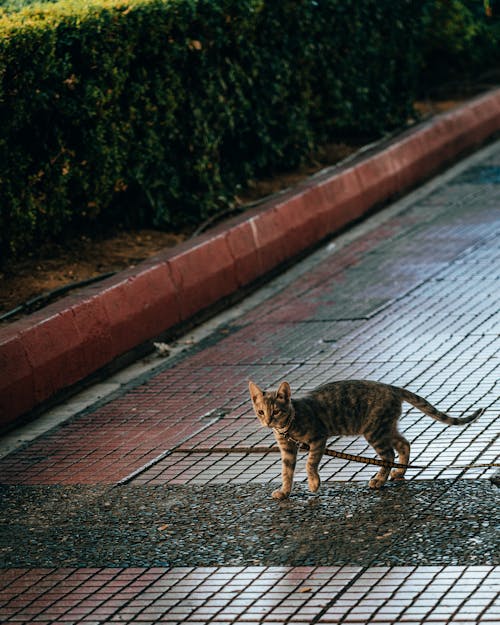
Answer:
0, 0, 425, 260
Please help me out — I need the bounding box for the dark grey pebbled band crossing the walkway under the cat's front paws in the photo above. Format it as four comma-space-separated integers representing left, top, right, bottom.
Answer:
0, 480, 500, 567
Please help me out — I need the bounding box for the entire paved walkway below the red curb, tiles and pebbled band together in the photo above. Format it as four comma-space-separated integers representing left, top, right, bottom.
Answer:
0, 142, 500, 625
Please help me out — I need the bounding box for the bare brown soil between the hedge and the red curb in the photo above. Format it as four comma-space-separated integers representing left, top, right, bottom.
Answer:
0, 100, 457, 324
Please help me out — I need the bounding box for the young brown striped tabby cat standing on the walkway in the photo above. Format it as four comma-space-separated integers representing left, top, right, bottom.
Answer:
248, 380, 483, 499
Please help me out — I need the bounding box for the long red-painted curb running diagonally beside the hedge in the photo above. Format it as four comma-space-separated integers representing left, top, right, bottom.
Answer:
0, 89, 500, 427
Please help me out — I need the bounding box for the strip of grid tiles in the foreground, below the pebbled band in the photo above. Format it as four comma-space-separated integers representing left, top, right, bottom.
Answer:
0, 566, 500, 625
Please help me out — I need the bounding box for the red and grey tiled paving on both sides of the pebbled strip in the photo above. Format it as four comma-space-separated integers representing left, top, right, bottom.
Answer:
0, 143, 500, 624
